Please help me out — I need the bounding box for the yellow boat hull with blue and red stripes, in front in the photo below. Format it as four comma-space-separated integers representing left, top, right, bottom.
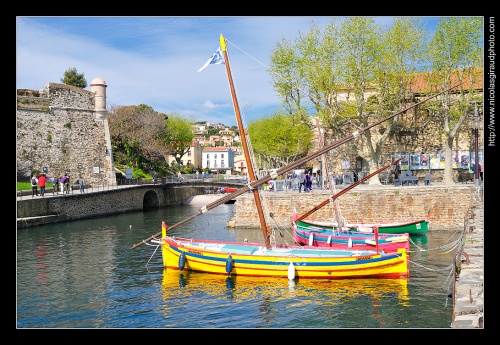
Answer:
162, 237, 409, 279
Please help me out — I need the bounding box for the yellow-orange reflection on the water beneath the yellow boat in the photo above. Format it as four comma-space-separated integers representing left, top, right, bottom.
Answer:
162, 269, 409, 306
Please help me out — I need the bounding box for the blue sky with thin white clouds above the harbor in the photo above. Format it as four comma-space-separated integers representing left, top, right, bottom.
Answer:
16, 16, 438, 126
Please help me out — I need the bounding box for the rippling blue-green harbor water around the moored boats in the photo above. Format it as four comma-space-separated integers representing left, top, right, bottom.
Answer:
16, 205, 461, 329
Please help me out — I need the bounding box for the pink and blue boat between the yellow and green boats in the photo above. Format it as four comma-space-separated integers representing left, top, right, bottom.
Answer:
293, 223, 410, 252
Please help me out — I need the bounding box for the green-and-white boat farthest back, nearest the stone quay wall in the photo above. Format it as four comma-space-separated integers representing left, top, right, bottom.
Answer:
297, 217, 429, 236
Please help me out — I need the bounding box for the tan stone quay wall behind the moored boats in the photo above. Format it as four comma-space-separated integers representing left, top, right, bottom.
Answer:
228, 184, 483, 230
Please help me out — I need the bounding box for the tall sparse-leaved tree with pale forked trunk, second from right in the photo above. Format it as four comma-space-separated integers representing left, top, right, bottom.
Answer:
354, 17, 428, 184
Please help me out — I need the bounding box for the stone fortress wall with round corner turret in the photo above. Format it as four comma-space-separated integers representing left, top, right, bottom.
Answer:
16, 78, 116, 185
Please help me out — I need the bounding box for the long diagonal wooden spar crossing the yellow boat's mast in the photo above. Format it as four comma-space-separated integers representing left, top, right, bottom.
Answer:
132, 40, 462, 249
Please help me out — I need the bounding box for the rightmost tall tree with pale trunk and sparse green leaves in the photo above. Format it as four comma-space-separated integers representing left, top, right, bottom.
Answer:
422, 17, 484, 185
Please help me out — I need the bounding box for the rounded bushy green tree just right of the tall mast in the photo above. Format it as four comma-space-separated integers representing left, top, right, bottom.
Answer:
248, 114, 312, 169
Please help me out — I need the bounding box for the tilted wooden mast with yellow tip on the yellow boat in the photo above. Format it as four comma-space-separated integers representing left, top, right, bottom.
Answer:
220, 34, 271, 249
